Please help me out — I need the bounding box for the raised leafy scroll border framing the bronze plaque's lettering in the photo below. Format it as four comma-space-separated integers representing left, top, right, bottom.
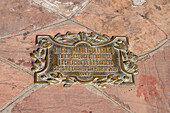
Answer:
30, 32, 138, 88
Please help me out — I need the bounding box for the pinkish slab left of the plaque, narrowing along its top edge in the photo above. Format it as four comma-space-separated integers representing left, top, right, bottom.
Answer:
0, 24, 90, 70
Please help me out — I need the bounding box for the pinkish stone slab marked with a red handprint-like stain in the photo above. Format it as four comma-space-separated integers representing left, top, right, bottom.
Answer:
104, 46, 170, 113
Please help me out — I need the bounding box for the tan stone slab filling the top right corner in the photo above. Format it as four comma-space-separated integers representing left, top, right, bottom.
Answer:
133, 0, 170, 35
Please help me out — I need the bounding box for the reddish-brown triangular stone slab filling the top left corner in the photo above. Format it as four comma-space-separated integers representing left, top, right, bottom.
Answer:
0, 0, 61, 36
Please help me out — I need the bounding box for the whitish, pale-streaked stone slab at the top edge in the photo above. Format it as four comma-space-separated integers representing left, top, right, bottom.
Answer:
33, 0, 87, 16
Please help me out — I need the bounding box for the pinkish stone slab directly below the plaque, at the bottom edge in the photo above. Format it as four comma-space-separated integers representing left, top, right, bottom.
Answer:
11, 85, 125, 113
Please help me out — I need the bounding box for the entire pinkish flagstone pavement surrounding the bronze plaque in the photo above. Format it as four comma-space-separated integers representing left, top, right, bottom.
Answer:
0, 0, 170, 113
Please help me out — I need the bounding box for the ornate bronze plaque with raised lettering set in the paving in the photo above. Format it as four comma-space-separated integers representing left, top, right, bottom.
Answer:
30, 32, 137, 87
